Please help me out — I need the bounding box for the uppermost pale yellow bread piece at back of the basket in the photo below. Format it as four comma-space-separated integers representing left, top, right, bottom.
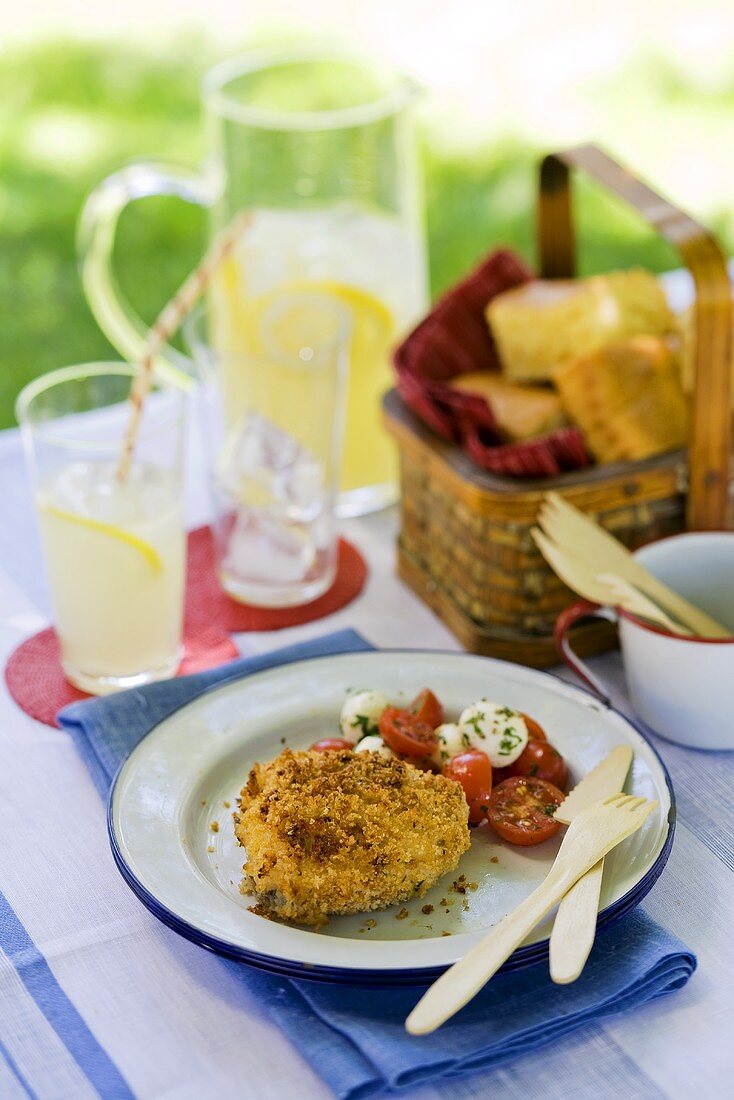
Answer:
485, 268, 675, 382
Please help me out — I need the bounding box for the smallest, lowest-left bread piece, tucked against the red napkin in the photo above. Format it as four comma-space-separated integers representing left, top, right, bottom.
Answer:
450, 371, 568, 441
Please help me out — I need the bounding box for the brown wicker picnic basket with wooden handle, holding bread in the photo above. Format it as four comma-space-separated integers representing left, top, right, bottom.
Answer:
384, 145, 732, 667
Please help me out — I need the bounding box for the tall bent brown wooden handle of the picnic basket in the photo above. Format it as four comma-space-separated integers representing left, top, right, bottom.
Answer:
538, 145, 732, 530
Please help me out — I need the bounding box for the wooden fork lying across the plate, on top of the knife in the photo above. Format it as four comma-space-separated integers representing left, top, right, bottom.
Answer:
405, 794, 657, 1035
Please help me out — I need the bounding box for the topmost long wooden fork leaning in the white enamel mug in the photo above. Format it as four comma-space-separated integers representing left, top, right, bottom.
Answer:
538, 493, 732, 638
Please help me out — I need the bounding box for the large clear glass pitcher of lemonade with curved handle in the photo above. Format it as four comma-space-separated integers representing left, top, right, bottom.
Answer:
79, 47, 427, 516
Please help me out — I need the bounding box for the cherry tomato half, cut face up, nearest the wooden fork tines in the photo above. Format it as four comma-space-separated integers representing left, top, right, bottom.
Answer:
486, 776, 566, 847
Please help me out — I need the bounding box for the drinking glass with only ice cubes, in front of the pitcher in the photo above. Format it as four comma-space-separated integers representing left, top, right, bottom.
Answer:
184, 290, 351, 607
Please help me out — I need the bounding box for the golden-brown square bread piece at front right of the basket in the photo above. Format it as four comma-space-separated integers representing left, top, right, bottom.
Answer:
556, 337, 688, 462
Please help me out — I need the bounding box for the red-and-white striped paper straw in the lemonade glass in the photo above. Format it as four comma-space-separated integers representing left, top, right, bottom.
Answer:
117, 211, 252, 483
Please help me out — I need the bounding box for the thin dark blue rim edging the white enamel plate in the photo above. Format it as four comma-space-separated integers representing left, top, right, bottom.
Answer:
106, 646, 677, 987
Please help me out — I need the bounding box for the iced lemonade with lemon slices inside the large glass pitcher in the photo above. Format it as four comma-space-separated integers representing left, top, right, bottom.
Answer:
210, 205, 425, 515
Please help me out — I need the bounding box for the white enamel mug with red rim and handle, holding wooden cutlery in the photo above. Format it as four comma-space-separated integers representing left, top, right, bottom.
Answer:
556, 531, 734, 749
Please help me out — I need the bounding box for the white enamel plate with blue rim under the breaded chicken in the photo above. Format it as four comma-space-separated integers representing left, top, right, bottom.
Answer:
108, 650, 675, 985
